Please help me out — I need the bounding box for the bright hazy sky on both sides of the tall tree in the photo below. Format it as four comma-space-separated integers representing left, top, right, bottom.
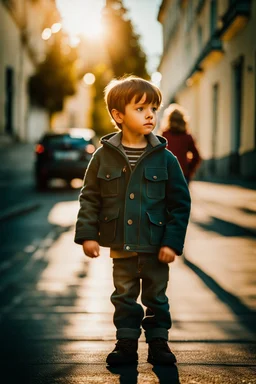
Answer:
56, 0, 162, 73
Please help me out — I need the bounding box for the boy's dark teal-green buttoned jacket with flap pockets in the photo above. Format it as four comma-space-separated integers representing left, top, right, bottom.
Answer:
75, 132, 190, 255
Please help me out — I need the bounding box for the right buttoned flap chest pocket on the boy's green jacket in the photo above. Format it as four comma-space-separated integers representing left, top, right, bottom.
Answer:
145, 168, 168, 200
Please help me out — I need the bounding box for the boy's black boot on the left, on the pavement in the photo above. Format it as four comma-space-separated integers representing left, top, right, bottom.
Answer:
106, 339, 138, 365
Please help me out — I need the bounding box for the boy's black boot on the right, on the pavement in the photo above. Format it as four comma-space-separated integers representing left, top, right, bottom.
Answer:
148, 338, 177, 365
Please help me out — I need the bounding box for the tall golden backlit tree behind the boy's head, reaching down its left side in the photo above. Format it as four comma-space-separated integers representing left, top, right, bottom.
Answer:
89, 0, 149, 135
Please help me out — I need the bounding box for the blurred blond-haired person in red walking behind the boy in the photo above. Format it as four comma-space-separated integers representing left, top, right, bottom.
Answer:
160, 103, 202, 183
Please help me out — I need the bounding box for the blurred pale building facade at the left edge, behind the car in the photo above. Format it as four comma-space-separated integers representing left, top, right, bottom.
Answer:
0, 0, 58, 142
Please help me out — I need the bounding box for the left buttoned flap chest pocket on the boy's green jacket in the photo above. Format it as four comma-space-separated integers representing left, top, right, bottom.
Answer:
97, 167, 122, 197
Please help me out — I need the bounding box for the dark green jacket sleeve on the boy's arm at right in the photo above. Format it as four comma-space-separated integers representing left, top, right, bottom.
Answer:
161, 156, 191, 255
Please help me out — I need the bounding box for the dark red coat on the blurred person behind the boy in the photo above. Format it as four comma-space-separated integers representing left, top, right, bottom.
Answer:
163, 131, 201, 180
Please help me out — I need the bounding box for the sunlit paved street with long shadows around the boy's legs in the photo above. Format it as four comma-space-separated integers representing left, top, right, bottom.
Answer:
0, 142, 256, 384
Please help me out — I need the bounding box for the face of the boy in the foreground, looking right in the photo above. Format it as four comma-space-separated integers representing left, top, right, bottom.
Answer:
113, 94, 158, 135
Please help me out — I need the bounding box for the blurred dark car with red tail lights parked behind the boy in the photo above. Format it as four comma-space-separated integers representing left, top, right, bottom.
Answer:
35, 128, 95, 189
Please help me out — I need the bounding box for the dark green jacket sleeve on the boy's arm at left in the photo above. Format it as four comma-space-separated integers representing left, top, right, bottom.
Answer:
74, 152, 101, 244
